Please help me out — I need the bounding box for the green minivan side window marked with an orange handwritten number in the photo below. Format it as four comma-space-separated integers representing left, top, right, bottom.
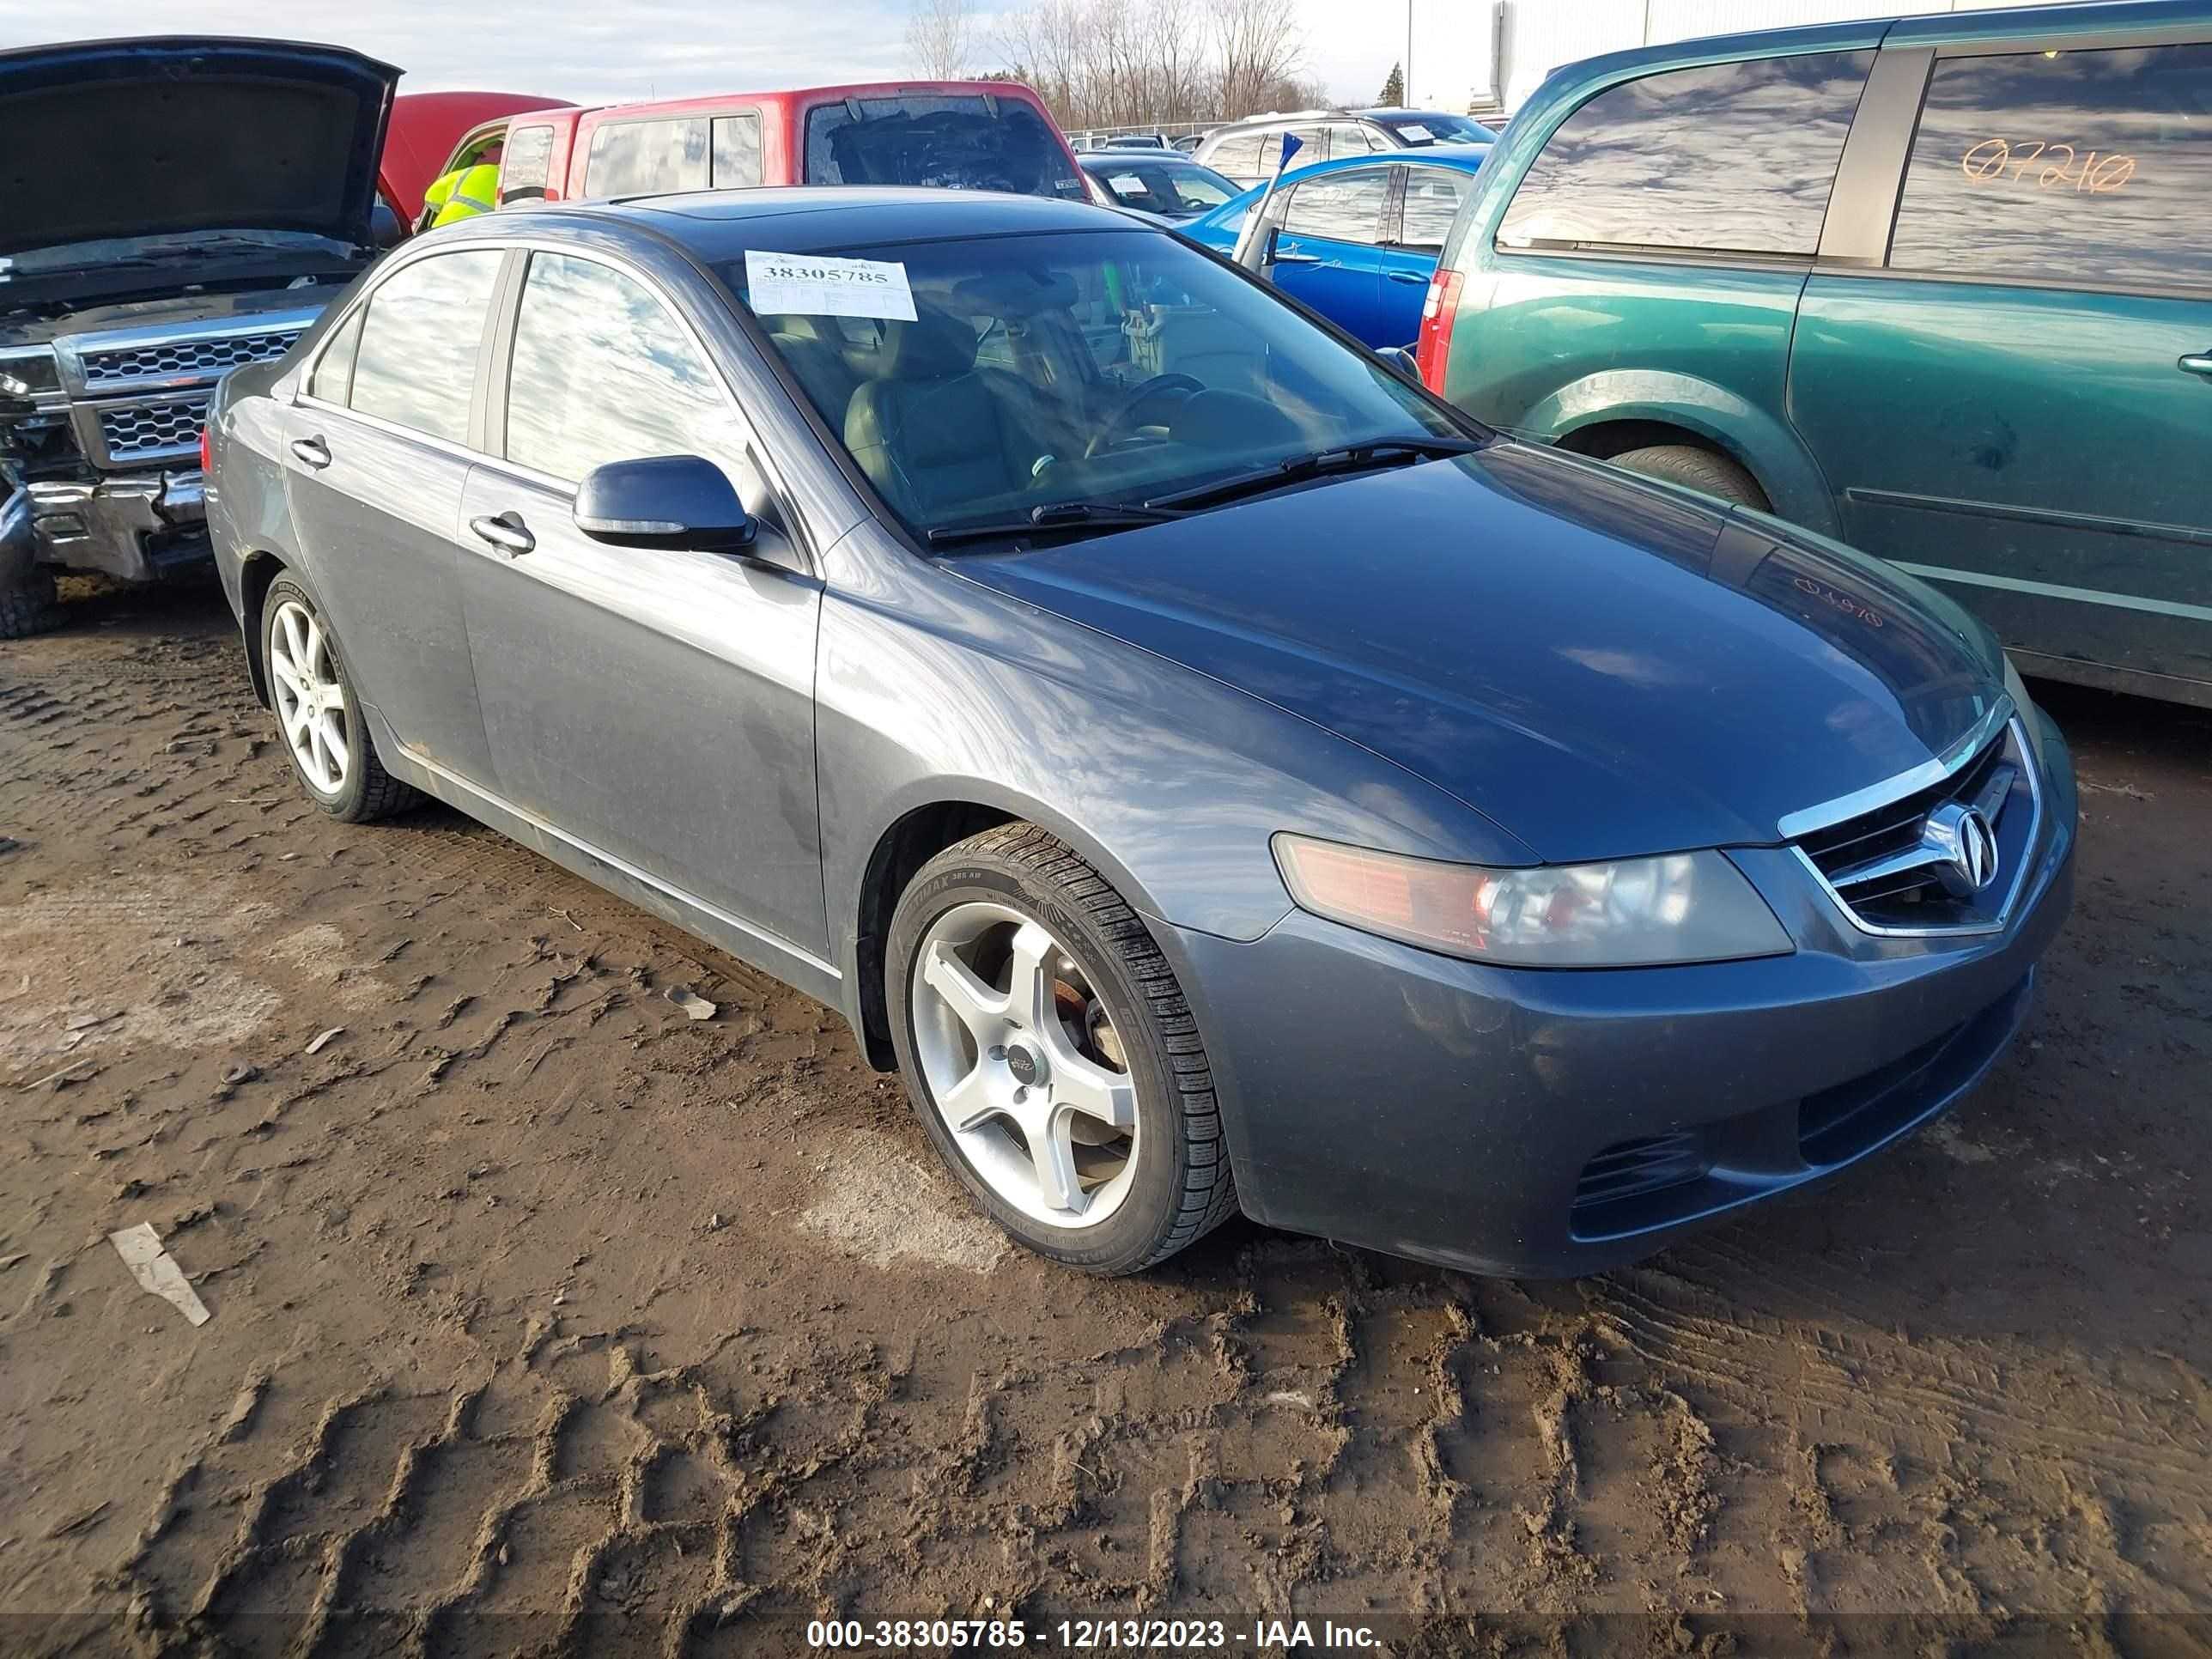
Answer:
1889, 45, 2212, 289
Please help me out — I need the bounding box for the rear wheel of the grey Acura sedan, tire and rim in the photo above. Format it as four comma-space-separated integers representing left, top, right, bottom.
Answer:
261, 577, 416, 823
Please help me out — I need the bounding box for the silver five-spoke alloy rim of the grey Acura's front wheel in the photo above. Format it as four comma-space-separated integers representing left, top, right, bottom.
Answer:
911, 900, 1139, 1228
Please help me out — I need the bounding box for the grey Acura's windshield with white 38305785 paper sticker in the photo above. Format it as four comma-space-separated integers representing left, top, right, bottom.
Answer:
721, 230, 1471, 540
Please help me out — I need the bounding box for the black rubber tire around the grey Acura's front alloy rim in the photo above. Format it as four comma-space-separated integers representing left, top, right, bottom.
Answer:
884, 823, 1237, 1276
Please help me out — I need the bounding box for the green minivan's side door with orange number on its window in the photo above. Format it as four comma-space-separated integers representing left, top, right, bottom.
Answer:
1790, 40, 2212, 696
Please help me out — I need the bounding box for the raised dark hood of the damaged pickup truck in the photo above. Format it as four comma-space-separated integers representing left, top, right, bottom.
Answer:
0, 35, 400, 254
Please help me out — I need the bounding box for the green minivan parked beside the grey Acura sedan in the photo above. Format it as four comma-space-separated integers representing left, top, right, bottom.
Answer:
1418, 0, 2212, 706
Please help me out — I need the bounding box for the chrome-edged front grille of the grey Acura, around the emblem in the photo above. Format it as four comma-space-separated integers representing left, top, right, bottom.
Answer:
1796, 721, 2039, 933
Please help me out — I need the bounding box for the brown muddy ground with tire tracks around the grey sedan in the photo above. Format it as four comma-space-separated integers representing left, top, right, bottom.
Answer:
0, 592, 2212, 1655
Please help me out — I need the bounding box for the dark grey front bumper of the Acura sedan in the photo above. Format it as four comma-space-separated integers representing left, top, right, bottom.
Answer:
1166, 714, 2075, 1276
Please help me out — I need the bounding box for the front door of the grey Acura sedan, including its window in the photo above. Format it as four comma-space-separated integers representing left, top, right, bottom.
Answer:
460, 240, 827, 956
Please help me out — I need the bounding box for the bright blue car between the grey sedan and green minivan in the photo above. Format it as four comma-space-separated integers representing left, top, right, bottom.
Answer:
1176, 143, 1491, 352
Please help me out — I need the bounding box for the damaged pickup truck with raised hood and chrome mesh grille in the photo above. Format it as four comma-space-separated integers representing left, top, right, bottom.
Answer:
0, 35, 400, 639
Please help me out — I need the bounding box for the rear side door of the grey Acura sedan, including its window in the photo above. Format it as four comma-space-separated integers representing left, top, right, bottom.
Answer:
283, 248, 507, 785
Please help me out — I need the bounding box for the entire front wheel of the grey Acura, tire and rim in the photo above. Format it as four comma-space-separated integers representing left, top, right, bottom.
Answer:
884, 823, 1237, 1274
